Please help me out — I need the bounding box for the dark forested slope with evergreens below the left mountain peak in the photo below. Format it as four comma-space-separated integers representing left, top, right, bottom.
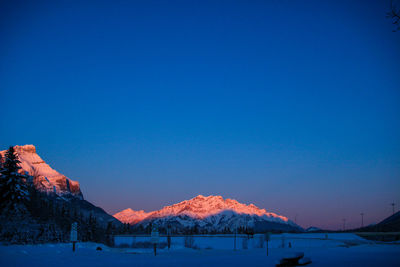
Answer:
0, 147, 123, 244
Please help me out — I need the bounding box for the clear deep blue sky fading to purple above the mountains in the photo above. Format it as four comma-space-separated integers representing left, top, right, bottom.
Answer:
0, 0, 400, 229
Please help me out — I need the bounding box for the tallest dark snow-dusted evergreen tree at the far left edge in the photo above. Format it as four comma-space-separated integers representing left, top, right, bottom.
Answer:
0, 146, 30, 215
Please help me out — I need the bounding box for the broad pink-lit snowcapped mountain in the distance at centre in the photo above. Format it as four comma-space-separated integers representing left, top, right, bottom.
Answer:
114, 195, 302, 231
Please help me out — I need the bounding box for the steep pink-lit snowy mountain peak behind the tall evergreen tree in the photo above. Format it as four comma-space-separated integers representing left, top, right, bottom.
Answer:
0, 145, 83, 199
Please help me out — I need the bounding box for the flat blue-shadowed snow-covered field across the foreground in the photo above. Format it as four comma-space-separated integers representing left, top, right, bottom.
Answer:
0, 234, 400, 267
